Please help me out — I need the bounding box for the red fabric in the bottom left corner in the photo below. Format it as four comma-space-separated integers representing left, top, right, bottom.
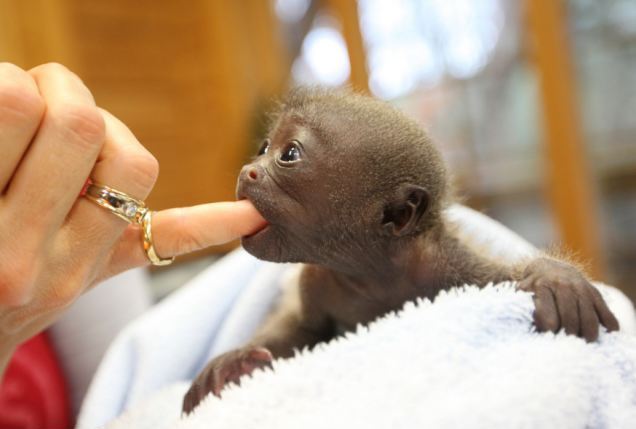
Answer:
0, 334, 71, 429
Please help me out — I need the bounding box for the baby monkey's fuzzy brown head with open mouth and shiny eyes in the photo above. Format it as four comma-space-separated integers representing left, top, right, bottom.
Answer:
237, 88, 447, 271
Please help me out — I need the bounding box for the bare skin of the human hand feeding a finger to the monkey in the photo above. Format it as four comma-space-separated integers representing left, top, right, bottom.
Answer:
0, 63, 266, 376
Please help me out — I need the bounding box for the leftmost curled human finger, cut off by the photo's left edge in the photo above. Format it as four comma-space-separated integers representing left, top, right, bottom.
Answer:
0, 63, 45, 194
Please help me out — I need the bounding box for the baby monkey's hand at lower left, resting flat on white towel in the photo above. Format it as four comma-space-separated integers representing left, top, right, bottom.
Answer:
182, 346, 273, 414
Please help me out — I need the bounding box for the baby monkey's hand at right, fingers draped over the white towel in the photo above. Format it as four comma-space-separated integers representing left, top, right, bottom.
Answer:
518, 258, 619, 342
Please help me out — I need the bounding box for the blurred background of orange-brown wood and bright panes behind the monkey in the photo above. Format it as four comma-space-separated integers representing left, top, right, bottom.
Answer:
0, 0, 636, 298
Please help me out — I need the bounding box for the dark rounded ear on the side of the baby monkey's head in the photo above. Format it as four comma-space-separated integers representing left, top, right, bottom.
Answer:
382, 185, 429, 237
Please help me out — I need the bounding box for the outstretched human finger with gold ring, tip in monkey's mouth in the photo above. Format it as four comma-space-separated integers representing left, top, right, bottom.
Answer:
106, 200, 267, 276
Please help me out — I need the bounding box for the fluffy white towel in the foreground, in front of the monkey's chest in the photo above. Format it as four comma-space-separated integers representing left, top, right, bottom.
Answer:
108, 283, 636, 429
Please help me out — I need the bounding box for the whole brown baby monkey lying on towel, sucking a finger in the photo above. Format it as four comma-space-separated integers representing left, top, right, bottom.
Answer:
183, 88, 618, 413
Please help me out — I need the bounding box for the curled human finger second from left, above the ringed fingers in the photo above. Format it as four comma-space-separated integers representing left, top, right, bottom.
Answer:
6, 64, 104, 237
